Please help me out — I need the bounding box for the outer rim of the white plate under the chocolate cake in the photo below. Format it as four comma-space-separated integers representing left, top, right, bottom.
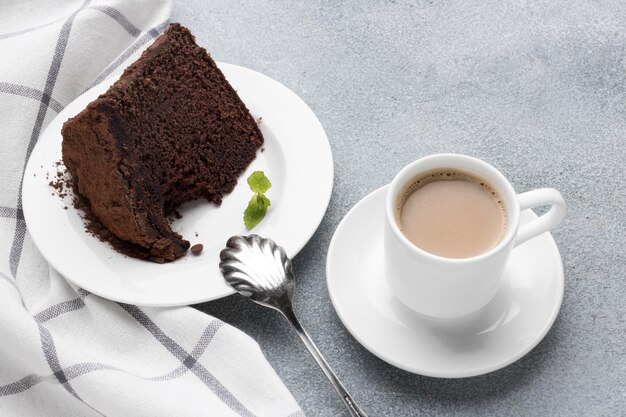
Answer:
23, 62, 334, 307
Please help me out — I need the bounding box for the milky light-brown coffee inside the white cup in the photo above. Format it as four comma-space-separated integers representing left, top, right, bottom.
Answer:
396, 168, 507, 258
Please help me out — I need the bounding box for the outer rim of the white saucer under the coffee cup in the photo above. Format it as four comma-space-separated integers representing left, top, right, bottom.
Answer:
326, 184, 565, 379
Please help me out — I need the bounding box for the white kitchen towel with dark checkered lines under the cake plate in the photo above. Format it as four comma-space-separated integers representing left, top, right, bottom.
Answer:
0, 0, 303, 417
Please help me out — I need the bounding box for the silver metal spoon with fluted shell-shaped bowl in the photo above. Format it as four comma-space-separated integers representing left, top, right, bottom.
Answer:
220, 235, 367, 417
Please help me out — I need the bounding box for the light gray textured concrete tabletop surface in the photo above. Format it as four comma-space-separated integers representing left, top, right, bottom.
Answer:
184, 0, 626, 417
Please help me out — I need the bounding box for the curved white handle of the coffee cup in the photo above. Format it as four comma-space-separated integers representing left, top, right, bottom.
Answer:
515, 188, 565, 246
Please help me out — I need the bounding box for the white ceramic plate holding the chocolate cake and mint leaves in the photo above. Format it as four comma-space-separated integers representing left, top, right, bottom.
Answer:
23, 64, 333, 306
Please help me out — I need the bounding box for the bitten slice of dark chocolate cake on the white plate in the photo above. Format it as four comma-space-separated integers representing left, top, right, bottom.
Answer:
62, 24, 263, 262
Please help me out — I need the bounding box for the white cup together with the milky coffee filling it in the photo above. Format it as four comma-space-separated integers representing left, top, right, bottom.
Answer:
383, 154, 565, 319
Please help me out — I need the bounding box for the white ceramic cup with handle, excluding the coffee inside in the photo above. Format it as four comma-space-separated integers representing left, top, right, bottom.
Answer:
384, 154, 565, 318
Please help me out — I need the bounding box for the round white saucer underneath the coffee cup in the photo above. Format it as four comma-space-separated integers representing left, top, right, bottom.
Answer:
326, 187, 563, 378
